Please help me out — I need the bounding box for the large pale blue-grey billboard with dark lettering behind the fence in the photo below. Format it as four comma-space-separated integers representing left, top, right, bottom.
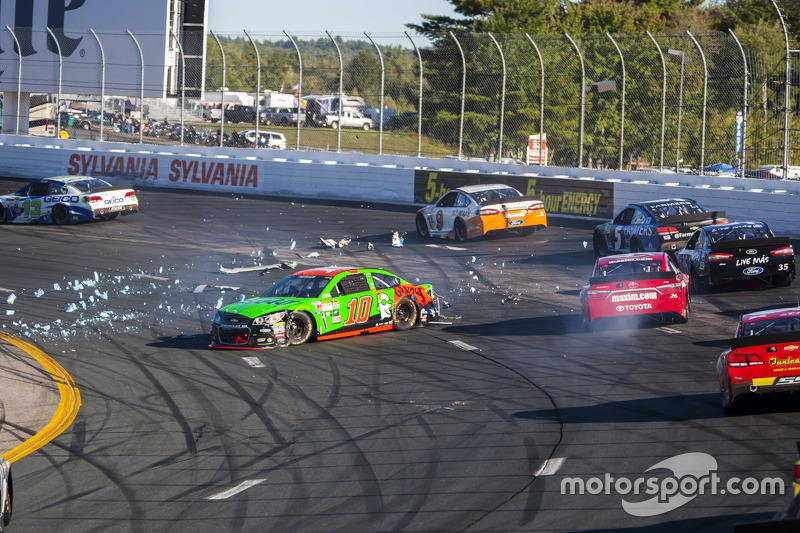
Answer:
0, 0, 169, 97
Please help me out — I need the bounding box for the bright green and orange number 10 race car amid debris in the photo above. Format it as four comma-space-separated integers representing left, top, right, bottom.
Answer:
211, 267, 439, 349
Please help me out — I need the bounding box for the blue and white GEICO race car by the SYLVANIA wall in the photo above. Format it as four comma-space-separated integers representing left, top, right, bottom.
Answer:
0, 176, 139, 224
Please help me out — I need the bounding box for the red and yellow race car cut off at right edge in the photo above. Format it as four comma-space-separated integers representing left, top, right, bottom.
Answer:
717, 307, 800, 412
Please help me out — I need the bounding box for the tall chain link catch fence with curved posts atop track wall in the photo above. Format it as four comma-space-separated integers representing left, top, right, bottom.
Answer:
0, 29, 800, 177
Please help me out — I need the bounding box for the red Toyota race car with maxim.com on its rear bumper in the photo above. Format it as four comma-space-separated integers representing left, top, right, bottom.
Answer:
580, 252, 691, 329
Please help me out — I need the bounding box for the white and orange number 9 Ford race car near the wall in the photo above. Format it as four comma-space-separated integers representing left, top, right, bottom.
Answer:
417, 184, 547, 241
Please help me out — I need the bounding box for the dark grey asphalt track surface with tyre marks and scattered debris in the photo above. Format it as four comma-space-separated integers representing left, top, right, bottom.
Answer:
0, 180, 800, 532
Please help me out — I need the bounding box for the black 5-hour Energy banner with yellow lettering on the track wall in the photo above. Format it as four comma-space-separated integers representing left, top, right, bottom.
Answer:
414, 170, 614, 219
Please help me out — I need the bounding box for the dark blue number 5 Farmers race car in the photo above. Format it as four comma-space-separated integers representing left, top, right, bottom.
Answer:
594, 198, 728, 257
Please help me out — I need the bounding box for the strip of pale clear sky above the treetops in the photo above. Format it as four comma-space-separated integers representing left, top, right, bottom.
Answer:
203, 0, 461, 34
